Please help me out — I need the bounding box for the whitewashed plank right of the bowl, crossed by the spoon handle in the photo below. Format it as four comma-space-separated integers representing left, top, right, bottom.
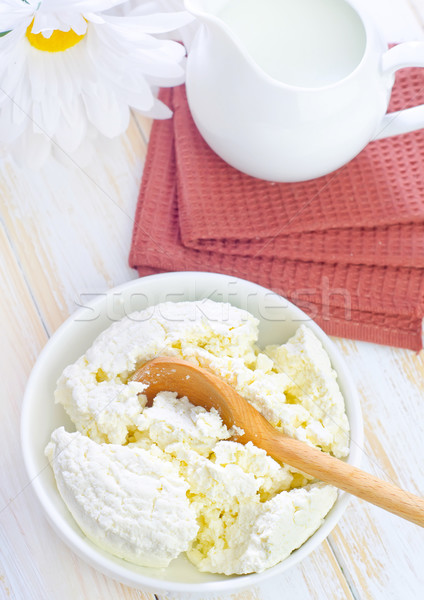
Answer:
330, 340, 424, 600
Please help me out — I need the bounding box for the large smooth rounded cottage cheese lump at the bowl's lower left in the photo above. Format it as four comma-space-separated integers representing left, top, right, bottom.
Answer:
46, 427, 199, 567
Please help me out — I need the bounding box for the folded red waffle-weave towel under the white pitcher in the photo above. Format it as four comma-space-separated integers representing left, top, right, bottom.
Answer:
130, 69, 424, 350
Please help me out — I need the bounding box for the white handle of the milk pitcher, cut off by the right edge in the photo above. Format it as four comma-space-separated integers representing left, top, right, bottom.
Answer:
373, 42, 424, 140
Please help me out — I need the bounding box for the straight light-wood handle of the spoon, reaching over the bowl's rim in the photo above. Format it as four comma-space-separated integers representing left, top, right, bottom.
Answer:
261, 430, 424, 527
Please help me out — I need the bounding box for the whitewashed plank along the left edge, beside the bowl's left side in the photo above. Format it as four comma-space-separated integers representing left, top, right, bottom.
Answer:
0, 225, 154, 600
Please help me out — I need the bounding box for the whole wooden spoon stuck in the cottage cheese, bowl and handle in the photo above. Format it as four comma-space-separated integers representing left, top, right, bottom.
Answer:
131, 357, 424, 527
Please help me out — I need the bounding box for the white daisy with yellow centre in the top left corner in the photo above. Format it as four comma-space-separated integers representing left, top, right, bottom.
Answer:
0, 0, 191, 165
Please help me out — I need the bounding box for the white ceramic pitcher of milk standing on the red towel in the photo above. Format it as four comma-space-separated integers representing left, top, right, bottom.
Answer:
185, 0, 424, 181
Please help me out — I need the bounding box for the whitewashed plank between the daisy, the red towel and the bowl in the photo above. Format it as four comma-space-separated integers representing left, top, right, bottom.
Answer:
0, 115, 146, 332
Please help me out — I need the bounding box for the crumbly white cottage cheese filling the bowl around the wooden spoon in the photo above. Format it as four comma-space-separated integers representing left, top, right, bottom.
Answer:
46, 300, 348, 575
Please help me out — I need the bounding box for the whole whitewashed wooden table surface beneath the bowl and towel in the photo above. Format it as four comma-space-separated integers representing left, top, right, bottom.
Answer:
0, 0, 424, 600
